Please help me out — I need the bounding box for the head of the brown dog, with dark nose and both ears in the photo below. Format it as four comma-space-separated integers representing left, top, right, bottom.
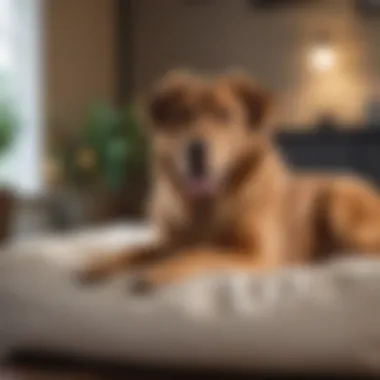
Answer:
140, 72, 271, 198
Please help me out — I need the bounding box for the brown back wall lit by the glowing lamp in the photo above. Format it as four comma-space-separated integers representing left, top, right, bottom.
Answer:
132, 0, 380, 128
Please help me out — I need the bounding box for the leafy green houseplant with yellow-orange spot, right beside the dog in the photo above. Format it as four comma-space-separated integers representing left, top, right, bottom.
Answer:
52, 102, 148, 223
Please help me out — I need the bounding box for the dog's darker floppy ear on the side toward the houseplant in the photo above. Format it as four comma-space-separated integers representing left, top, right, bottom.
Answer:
142, 70, 193, 126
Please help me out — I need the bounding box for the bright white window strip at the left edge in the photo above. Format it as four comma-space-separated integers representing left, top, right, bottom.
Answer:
0, 0, 43, 196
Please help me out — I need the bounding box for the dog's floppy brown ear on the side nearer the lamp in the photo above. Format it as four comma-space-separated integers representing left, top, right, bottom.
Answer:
227, 74, 273, 129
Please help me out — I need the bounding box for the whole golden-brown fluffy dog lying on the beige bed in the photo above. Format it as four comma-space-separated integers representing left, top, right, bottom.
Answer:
81, 72, 380, 287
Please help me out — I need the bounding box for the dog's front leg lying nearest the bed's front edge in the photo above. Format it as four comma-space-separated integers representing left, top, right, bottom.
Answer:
132, 248, 279, 292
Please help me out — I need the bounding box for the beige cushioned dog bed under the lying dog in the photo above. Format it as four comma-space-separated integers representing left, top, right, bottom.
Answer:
0, 225, 380, 373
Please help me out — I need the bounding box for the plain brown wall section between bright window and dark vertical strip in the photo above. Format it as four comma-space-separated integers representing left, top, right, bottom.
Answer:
45, 0, 117, 122
